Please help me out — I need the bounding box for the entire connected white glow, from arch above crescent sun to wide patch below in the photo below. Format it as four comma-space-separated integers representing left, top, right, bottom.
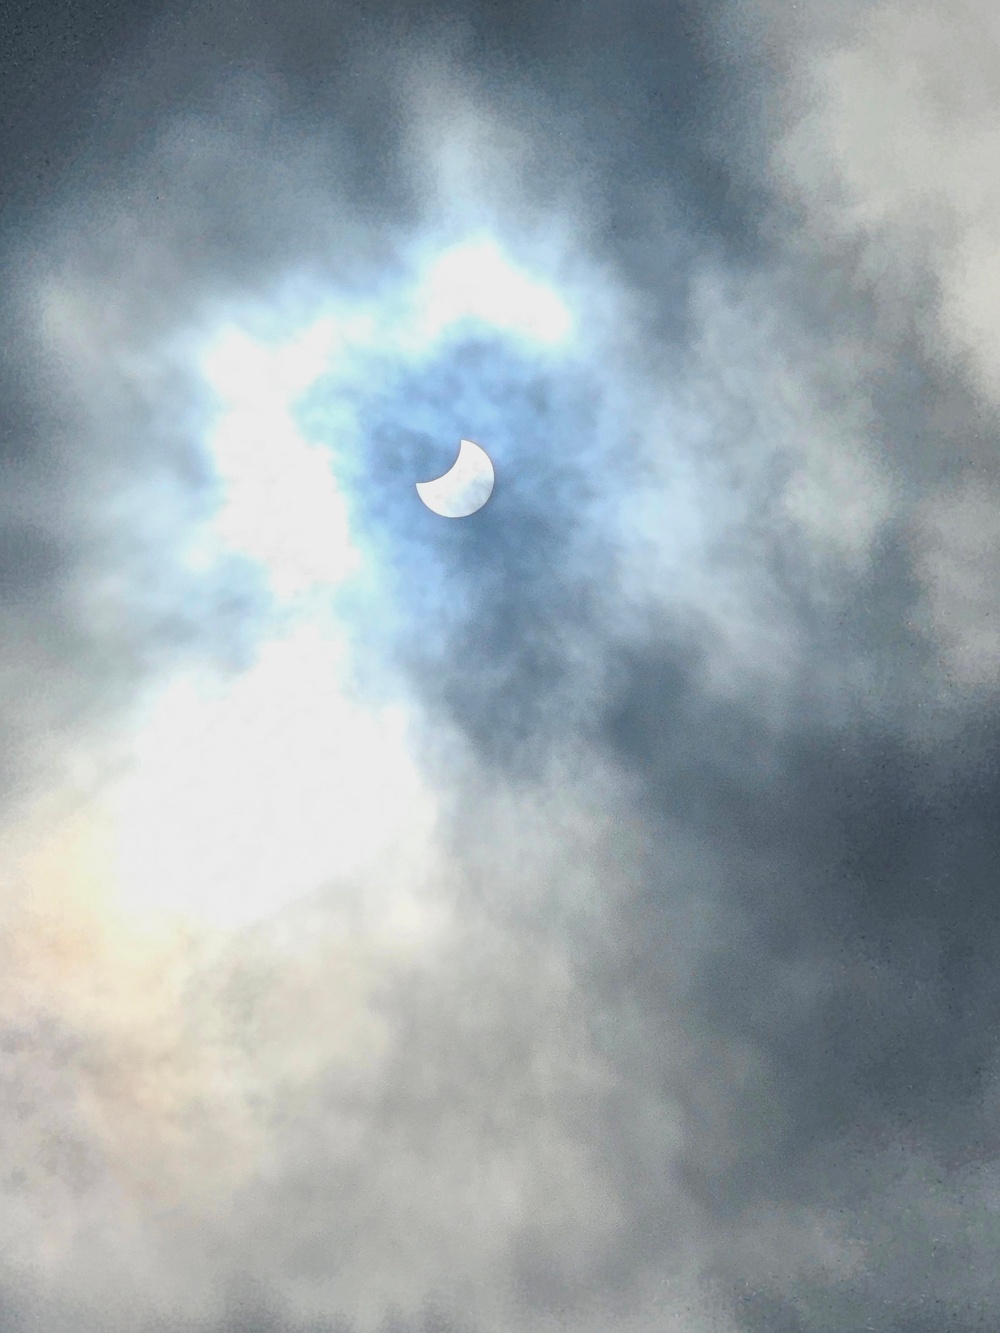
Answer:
41, 241, 571, 933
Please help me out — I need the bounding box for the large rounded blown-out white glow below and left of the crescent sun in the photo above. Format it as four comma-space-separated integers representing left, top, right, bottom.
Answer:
111, 627, 435, 926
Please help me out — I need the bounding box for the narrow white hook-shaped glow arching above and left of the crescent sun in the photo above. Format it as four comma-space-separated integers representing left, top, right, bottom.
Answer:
189, 240, 572, 599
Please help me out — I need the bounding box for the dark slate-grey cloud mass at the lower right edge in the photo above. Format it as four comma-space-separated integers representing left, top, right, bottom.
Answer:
586, 653, 997, 1306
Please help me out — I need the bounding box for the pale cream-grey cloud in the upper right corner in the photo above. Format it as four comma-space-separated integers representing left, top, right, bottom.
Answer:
757, 4, 997, 688
